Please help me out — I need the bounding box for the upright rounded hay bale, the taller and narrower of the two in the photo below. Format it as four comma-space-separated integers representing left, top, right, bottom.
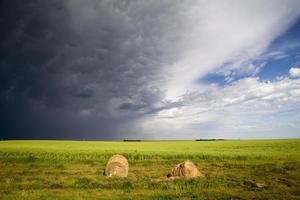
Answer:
104, 155, 128, 177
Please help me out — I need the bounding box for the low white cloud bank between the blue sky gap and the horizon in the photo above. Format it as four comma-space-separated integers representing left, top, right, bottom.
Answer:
142, 77, 300, 138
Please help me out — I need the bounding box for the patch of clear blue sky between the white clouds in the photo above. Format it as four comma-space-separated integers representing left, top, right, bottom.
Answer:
197, 19, 300, 85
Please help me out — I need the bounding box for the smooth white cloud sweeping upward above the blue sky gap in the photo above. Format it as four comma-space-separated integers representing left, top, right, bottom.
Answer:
165, 0, 300, 98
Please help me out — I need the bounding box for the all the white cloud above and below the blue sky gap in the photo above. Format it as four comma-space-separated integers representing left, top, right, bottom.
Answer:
138, 1, 300, 138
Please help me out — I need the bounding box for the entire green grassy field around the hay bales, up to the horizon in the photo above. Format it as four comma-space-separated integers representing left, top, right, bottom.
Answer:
0, 139, 300, 199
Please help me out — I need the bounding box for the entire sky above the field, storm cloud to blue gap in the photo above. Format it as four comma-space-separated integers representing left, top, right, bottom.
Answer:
0, 0, 300, 140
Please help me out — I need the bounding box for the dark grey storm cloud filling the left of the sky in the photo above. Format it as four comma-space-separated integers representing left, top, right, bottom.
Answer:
0, 0, 183, 139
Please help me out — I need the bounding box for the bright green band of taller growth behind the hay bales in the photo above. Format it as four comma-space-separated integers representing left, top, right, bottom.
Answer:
0, 140, 300, 162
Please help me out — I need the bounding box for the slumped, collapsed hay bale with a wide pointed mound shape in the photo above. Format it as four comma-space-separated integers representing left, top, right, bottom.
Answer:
168, 160, 204, 178
